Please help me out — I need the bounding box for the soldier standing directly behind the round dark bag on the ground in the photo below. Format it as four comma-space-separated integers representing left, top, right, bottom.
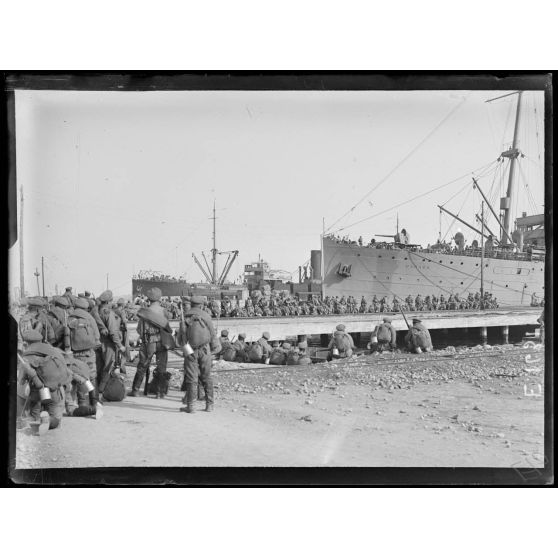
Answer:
94, 290, 126, 393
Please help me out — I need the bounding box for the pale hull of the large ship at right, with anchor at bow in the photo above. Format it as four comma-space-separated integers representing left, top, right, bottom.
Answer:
323, 238, 544, 306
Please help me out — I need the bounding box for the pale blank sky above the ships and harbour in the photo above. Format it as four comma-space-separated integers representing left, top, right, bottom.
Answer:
10, 91, 544, 294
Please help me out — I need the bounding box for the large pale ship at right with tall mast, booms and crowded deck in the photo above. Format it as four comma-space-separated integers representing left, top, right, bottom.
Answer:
311, 91, 545, 306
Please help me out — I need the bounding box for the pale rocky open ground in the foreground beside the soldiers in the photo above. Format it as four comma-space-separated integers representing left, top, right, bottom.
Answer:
16, 345, 544, 468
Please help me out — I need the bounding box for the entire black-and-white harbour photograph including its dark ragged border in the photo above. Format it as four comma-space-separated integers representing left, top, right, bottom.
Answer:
6, 73, 553, 484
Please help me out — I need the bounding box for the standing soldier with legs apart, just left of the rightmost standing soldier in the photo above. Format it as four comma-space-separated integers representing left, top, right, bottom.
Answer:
128, 287, 174, 399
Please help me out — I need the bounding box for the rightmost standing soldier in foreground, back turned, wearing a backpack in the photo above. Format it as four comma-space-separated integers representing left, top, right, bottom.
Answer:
178, 296, 220, 413
